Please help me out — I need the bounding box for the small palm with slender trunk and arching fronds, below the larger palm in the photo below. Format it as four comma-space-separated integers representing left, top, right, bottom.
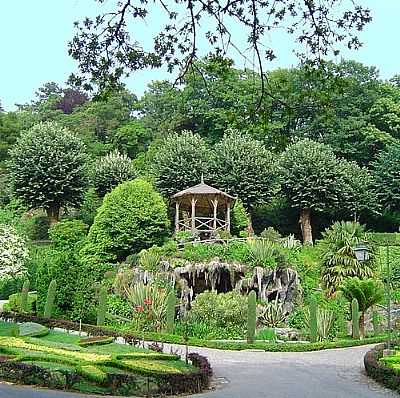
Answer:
340, 277, 384, 337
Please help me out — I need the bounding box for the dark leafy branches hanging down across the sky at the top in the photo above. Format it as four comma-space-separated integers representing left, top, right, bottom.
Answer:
69, 0, 371, 95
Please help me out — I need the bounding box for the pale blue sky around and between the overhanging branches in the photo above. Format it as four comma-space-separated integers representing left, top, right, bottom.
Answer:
0, 0, 400, 110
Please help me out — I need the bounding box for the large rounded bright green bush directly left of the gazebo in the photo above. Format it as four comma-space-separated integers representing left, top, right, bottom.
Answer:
86, 179, 169, 262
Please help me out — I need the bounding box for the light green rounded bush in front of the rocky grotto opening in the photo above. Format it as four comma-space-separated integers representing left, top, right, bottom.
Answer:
189, 291, 247, 338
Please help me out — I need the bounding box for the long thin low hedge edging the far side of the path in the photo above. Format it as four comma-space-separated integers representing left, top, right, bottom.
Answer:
0, 312, 386, 352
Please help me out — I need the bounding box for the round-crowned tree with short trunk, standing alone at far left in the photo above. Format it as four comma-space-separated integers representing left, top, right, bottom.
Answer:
9, 122, 87, 223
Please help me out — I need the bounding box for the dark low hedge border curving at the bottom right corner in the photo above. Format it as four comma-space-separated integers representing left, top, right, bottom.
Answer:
364, 344, 400, 392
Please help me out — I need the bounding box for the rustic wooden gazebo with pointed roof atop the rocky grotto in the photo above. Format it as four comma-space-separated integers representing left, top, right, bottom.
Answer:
172, 177, 235, 235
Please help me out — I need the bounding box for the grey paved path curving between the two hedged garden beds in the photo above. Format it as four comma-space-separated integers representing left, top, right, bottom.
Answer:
0, 346, 399, 398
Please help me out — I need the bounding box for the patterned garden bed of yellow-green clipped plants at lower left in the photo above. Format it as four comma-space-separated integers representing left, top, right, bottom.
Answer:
0, 327, 211, 396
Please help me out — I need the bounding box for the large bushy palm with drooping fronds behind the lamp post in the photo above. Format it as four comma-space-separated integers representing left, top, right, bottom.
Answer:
319, 221, 374, 296
